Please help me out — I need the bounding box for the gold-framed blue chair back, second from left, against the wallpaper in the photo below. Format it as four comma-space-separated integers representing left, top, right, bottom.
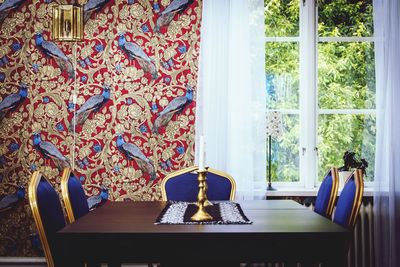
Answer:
61, 168, 89, 223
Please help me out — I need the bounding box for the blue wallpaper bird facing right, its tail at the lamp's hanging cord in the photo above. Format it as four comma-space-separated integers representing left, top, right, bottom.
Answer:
68, 85, 110, 132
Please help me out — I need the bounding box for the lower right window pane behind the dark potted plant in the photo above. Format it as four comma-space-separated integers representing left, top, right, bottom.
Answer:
318, 114, 375, 181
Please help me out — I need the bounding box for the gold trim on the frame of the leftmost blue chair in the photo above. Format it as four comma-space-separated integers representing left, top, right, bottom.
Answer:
28, 171, 54, 267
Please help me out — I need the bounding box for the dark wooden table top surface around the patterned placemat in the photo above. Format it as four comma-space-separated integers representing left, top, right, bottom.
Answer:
59, 200, 348, 234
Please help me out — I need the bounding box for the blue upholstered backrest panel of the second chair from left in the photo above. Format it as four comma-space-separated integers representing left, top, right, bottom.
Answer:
68, 173, 89, 220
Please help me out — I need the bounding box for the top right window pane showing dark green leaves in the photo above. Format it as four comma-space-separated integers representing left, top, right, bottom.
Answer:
318, 0, 373, 37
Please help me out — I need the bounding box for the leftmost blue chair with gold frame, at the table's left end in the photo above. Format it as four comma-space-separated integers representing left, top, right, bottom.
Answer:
28, 171, 66, 267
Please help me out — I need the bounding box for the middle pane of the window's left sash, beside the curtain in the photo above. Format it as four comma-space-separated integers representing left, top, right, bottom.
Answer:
265, 42, 299, 109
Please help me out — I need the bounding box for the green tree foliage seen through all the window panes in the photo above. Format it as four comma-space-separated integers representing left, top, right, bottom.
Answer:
264, 0, 376, 181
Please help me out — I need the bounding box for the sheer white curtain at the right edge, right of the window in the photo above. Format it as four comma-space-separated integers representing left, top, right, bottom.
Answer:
373, 0, 400, 267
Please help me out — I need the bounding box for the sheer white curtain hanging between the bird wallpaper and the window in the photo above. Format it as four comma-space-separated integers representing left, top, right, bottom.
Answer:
196, 0, 266, 199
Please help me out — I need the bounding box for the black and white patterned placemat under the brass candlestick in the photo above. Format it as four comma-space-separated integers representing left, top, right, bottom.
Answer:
155, 202, 253, 224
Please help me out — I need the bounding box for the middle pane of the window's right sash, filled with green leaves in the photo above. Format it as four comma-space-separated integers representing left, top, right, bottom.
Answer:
318, 42, 375, 109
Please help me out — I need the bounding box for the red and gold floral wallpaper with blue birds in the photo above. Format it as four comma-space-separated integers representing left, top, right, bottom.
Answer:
0, 0, 201, 256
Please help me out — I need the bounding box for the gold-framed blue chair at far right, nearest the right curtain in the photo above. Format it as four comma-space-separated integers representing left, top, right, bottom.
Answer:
333, 169, 364, 228
